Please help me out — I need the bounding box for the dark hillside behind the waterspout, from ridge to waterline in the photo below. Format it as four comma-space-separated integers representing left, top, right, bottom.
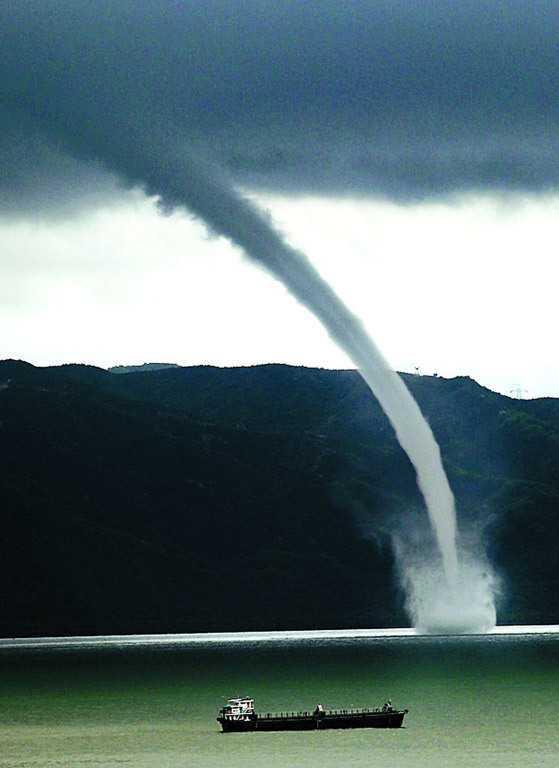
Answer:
0, 361, 559, 636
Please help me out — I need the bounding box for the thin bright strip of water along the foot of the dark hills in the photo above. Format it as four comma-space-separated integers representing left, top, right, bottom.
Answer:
0, 624, 559, 651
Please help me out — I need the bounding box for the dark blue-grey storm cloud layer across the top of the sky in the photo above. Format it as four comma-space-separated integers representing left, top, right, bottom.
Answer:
0, 0, 559, 209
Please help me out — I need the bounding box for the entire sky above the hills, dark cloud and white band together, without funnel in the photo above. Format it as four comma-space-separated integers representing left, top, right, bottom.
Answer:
0, 6, 559, 396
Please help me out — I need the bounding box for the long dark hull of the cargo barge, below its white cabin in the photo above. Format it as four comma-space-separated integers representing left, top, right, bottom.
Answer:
218, 710, 407, 733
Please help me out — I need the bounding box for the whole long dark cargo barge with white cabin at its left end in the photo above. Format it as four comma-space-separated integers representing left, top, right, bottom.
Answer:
217, 696, 408, 733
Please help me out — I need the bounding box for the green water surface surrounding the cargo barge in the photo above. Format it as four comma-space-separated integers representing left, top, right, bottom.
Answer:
0, 632, 559, 768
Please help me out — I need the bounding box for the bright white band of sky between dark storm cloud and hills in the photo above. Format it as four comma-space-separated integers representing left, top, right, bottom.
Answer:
0, 190, 559, 402
